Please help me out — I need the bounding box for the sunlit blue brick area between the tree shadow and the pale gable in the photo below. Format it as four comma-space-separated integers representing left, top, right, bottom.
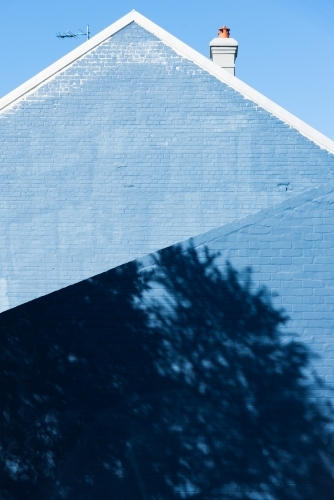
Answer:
141, 182, 334, 392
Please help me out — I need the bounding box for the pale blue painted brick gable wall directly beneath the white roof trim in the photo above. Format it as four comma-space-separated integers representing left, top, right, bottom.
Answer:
0, 24, 334, 310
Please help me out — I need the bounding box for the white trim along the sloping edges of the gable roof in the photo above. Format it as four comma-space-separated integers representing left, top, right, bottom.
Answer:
0, 10, 334, 154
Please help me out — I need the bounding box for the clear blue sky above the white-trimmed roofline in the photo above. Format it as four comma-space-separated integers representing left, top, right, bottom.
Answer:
0, 0, 334, 139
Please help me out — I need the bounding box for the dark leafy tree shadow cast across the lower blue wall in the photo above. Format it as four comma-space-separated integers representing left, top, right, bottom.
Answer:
0, 247, 334, 500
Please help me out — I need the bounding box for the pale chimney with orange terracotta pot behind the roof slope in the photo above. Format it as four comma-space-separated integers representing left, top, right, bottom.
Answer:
210, 26, 238, 76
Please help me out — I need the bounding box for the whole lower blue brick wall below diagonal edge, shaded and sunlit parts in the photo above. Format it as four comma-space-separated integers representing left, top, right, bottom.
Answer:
0, 183, 334, 500
